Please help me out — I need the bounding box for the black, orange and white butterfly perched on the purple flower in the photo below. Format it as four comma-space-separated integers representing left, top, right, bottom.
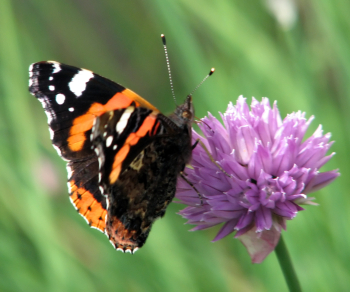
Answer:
29, 61, 194, 253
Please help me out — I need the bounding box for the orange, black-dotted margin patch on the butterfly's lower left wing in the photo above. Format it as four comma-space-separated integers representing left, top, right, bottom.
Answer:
70, 181, 107, 232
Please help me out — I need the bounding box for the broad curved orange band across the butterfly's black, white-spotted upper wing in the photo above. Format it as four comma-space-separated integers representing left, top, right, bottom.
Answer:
68, 89, 159, 151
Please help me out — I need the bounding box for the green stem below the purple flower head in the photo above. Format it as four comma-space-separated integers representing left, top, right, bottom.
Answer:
275, 234, 301, 292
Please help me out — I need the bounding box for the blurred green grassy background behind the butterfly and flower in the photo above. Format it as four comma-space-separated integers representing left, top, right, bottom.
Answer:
0, 0, 350, 292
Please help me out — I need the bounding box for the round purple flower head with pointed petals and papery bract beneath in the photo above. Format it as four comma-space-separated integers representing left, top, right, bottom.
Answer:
176, 96, 339, 263
